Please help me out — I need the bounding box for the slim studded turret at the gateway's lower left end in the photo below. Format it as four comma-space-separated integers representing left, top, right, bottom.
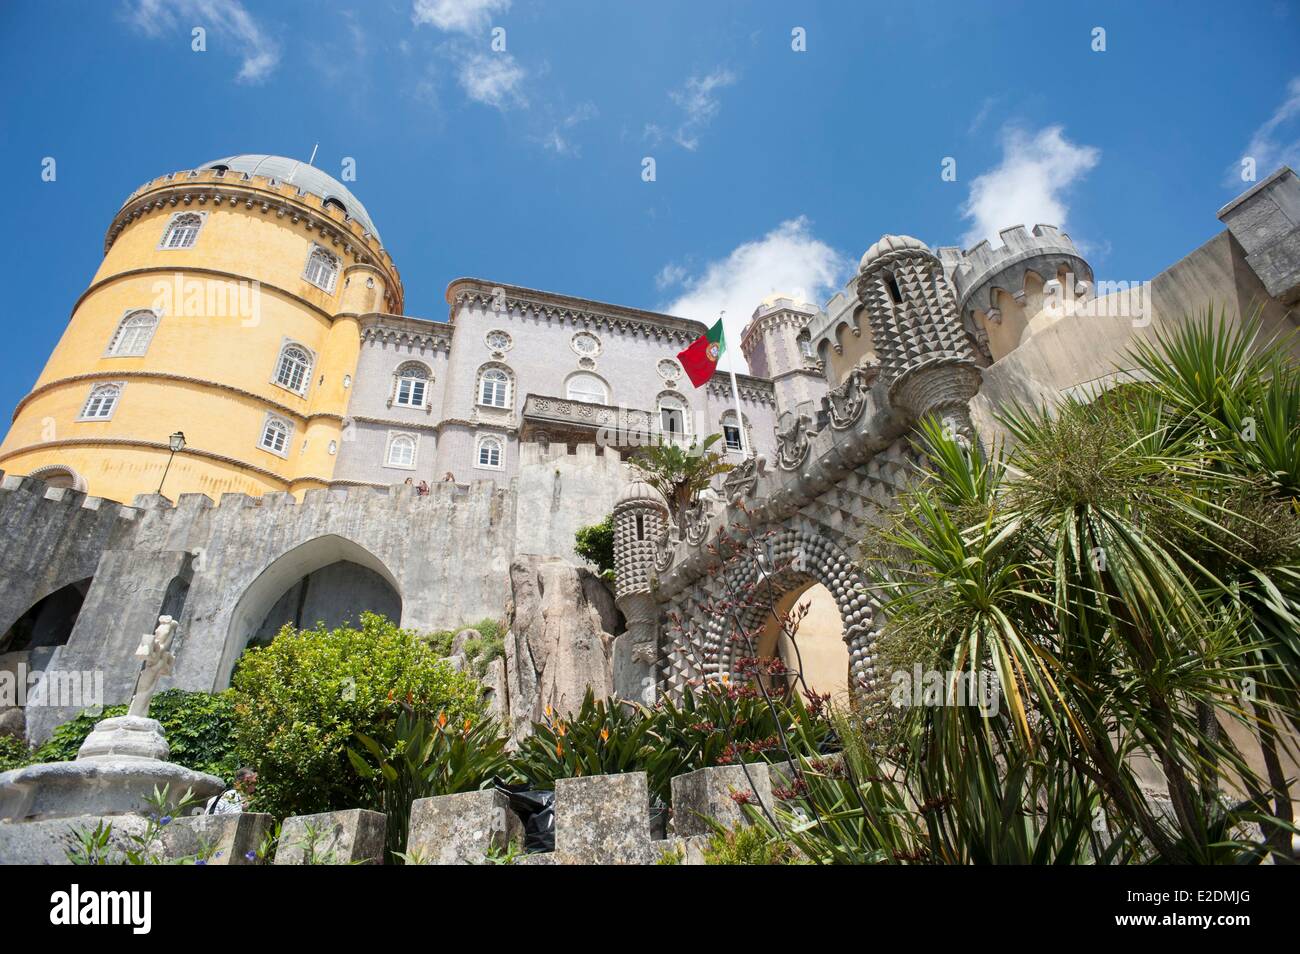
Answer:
614, 480, 668, 702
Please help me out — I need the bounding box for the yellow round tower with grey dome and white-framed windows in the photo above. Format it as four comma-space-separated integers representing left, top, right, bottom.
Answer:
0, 155, 402, 503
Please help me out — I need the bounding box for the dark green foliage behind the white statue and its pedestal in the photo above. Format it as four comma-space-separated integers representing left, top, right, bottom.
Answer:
31, 689, 239, 781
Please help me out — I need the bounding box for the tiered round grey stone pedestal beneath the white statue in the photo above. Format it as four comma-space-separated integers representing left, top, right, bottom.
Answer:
0, 716, 225, 821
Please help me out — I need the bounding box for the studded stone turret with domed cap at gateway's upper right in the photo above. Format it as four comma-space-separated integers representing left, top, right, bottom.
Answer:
857, 235, 980, 441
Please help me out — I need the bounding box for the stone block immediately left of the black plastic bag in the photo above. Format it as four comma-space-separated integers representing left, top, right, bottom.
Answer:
407, 789, 524, 864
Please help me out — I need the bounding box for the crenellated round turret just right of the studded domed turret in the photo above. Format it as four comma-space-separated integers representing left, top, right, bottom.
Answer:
939, 225, 1092, 361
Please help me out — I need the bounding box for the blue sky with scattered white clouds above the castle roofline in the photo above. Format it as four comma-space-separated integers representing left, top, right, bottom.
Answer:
0, 0, 1300, 408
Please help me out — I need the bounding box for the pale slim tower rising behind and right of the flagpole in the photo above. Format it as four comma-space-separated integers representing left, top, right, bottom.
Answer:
740, 294, 826, 417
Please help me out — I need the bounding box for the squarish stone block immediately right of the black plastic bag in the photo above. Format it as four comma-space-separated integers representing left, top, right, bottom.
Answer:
555, 772, 655, 864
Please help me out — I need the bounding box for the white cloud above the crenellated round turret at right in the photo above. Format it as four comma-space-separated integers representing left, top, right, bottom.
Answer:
962, 126, 1101, 247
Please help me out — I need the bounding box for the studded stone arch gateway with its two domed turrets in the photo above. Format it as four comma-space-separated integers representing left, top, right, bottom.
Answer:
615, 235, 980, 695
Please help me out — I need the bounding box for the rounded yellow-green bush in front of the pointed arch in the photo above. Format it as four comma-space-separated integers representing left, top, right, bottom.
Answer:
234, 613, 481, 818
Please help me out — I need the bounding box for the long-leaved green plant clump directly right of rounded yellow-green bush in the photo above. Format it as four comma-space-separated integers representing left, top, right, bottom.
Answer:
347, 706, 506, 858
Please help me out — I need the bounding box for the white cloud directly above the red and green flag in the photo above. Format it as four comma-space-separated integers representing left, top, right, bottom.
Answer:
655, 216, 853, 370
